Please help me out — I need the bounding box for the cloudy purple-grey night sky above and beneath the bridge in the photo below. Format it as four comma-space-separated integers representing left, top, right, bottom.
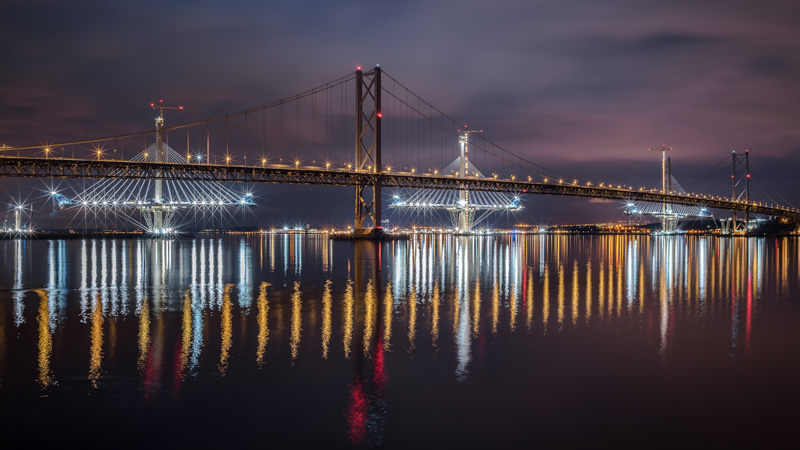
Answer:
0, 0, 800, 229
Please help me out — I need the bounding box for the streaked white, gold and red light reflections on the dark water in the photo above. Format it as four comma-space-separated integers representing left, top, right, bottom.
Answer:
0, 234, 800, 443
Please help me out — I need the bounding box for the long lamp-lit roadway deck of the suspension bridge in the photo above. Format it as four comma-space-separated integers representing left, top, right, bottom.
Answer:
0, 156, 800, 220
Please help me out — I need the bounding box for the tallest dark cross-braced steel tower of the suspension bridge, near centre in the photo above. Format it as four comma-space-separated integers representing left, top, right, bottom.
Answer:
355, 66, 383, 235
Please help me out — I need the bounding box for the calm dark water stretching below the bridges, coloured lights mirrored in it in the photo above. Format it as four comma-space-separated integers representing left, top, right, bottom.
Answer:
0, 235, 800, 448
